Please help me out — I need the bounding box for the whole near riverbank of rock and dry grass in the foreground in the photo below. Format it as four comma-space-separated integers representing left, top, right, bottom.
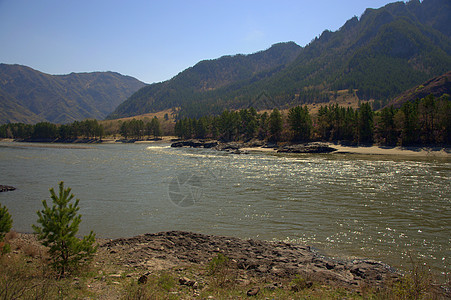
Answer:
6, 231, 451, 300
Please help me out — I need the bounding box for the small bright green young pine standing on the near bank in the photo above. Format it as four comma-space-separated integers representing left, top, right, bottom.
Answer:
32, 181, 97, 276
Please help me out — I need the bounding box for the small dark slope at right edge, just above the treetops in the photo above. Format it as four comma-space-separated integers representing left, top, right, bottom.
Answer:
389, 71, 451, 108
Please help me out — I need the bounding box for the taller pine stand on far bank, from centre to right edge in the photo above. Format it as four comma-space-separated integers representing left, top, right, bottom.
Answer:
174, 95, 451, 146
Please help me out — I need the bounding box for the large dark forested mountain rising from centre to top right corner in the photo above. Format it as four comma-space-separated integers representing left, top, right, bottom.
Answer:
109, 0, 451, 118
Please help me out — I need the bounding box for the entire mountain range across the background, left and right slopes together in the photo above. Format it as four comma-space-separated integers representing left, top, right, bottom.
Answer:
0, 0, 451, 123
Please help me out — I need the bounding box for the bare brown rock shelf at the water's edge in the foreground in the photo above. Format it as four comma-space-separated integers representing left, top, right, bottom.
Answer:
102, 231, 398, 287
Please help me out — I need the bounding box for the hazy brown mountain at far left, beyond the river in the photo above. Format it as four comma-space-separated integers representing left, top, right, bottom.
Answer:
0, 64, 145, 123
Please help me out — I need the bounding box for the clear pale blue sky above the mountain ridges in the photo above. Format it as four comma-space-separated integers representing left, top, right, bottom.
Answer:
0, 0, 393, 83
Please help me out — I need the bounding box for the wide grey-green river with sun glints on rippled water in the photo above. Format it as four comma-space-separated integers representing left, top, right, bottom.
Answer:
0, 142, 451, 273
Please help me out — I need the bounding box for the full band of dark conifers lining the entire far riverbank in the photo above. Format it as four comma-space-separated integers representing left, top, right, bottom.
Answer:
0, 94, 451, 146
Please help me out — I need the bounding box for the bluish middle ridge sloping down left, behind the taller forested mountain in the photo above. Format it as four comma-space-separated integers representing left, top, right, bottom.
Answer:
109, 42, 302, 118
